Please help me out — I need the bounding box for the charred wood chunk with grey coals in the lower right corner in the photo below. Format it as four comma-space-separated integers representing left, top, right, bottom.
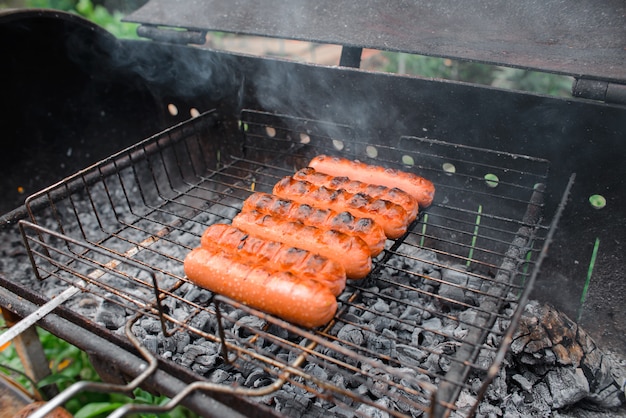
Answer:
457, 301, 626, 418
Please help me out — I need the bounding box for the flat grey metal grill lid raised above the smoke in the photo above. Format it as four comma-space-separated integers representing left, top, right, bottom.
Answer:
127, 0, 626, 81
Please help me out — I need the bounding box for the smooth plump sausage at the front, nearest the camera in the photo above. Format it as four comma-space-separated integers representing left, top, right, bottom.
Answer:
184, 246, 337, 328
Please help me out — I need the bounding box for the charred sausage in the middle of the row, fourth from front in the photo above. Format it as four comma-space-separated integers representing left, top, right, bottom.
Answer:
241, 192, 387, 257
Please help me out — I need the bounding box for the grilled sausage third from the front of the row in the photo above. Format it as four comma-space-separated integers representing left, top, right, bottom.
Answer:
232, 211, 372, 279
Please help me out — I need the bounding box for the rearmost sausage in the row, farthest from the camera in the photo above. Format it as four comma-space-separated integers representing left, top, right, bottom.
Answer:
309, 155, 435, 208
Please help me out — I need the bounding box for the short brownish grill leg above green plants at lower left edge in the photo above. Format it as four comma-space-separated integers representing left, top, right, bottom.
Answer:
2, 309, 59, 399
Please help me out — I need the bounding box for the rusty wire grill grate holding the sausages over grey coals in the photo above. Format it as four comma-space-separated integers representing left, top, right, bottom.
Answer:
21, 111, 548, 416
